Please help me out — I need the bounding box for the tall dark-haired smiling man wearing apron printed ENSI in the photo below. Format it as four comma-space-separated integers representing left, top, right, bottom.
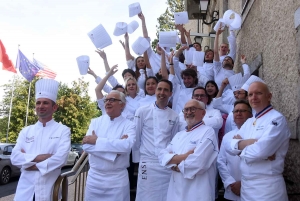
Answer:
132, 79, 178, 201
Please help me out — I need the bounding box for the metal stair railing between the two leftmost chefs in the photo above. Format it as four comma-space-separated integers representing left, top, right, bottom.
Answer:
53, 152, 89, 201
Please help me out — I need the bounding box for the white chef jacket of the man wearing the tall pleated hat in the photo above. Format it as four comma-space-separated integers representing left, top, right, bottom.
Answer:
10, 119, 71, 201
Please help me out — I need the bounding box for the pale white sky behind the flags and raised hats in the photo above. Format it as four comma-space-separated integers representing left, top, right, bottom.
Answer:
0, 0, 167, 100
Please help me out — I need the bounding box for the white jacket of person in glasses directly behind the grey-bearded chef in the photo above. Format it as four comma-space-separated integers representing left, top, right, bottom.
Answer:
179, 109, 223, 139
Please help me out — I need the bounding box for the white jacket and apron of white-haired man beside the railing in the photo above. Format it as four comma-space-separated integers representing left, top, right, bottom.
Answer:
83, 115, 135, 201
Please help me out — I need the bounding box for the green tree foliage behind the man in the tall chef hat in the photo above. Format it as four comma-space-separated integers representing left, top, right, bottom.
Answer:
0, 76, 101, 142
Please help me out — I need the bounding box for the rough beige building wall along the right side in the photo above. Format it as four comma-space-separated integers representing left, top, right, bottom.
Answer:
216, 0, 300, 196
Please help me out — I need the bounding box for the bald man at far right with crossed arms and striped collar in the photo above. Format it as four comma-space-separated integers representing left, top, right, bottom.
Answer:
225, 82, 290, 201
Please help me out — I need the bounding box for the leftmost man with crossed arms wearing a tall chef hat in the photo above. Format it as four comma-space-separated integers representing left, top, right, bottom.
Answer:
10, 79, 71, 201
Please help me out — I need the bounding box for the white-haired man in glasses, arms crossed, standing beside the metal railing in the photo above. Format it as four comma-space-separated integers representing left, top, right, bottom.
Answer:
82, 90, 135, 201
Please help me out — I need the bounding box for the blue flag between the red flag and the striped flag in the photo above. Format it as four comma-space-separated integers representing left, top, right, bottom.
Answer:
16, 50, 40, 82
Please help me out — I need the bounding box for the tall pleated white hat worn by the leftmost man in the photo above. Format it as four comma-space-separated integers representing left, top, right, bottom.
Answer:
35, 79, 59, 102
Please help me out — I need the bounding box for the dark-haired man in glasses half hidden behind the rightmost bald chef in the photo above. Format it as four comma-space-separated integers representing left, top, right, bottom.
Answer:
217, 100, 252, 201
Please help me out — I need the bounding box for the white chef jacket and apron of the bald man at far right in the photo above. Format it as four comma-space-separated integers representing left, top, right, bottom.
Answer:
229, 107, 290, 201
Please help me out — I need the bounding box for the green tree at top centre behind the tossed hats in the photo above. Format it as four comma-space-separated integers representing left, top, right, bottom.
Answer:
151, 0, 184, 50
